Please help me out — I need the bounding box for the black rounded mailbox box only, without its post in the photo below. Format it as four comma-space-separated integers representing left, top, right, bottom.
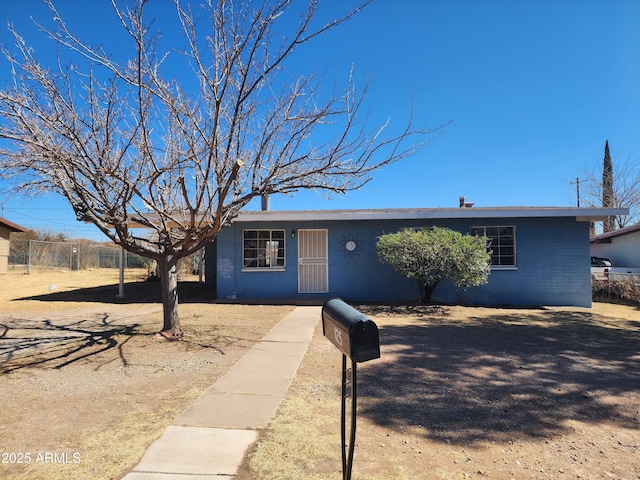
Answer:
322, 298, 380, 362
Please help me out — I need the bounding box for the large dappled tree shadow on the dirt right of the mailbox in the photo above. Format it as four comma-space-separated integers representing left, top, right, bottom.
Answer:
358, 311, 640, 445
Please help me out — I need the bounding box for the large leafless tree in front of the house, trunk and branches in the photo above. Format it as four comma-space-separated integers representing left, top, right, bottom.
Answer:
0, 0, 439, 337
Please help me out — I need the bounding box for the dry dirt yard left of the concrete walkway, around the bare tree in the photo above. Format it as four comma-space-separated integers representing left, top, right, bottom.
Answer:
0, 270, 292, 480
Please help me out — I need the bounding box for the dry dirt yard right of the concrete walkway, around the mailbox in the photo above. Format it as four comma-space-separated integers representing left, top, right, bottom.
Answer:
239, 304, 640, 480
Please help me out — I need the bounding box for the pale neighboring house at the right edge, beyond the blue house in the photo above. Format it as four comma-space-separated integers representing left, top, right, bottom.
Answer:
591, 223, 640, 268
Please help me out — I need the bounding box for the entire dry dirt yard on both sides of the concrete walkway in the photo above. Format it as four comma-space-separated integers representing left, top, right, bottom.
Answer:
0, 271, 640, 480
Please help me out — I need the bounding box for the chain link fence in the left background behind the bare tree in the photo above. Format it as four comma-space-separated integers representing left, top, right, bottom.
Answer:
8, 240, 148, 272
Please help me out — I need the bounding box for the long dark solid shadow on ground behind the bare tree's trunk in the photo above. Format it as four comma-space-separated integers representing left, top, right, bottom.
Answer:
14, 281, 215, 304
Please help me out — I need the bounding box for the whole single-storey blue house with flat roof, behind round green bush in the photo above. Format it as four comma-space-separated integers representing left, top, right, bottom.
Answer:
205, 205, 625, 307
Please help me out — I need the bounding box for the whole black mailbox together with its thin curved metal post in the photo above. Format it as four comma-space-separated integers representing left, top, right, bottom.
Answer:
322, 298, 380, 480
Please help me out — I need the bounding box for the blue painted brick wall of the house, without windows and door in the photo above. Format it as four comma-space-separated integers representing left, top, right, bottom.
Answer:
208, 217, 591, 307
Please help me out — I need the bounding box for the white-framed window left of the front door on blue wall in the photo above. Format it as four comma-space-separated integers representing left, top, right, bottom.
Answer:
242, 230, 285, 269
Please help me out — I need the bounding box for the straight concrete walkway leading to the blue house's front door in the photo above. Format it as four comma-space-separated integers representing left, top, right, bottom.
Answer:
124, 307, 321, 480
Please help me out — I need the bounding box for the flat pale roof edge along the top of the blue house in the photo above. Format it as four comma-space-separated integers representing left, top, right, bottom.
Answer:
234, 207, 628, 222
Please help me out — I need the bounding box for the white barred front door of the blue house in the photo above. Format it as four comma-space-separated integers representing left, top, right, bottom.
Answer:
298, 230, 329, 293
